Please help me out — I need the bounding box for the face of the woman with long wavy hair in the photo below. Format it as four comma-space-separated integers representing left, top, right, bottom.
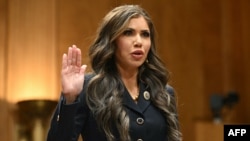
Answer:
115, 16, 151, 69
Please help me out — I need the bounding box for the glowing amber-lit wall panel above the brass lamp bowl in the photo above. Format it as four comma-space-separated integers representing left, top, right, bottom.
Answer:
6, 0, 59, 103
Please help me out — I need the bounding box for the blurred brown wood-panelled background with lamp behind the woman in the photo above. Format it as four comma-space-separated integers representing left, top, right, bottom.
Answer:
0, 0, 250, 141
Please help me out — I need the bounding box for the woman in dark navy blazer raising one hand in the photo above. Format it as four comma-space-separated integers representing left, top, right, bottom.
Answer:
47, 5, 181, 141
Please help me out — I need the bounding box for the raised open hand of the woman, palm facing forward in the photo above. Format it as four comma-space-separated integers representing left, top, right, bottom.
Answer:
61, 45, 87, 104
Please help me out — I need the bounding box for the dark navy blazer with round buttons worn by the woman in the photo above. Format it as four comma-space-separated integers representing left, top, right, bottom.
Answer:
47, 75, 174, 141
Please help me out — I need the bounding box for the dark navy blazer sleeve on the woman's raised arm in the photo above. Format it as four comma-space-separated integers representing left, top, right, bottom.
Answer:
47, 75, 90, 141
